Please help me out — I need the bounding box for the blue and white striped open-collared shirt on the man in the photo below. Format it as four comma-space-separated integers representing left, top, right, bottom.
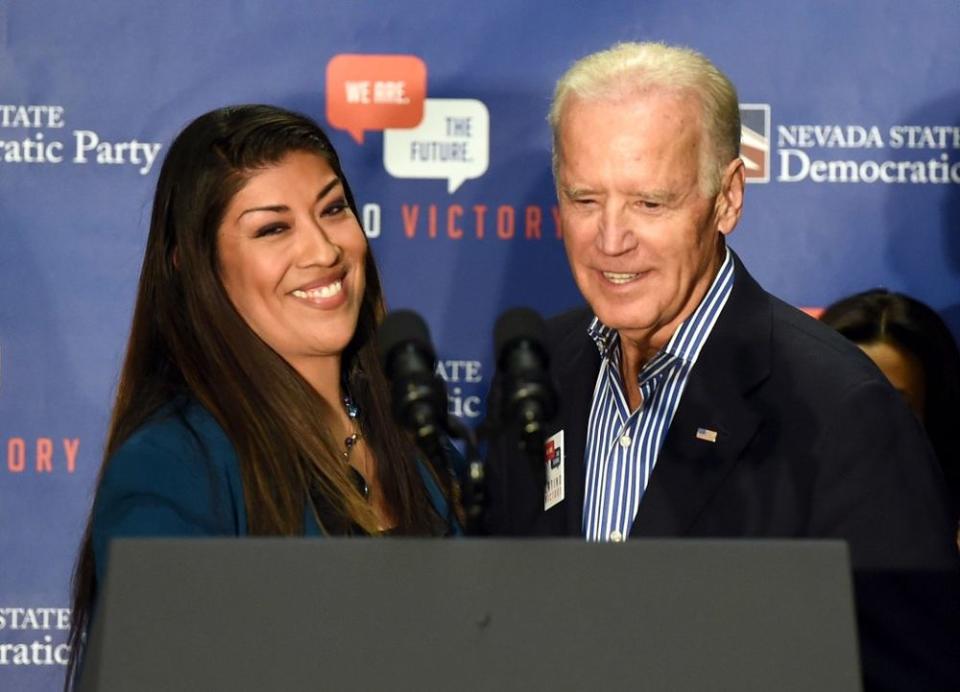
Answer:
582, 249, 733, 541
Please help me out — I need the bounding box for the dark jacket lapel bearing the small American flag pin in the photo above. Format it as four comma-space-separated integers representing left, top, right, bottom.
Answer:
631, 256, 771, 536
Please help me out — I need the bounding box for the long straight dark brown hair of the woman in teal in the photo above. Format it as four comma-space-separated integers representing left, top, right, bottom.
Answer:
67, 105, 448, 687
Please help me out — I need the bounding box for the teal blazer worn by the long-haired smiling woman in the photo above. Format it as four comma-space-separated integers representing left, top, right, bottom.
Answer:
92, 402, 460, 584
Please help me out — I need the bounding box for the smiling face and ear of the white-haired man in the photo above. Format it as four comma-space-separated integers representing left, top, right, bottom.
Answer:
557, 90, 743, 349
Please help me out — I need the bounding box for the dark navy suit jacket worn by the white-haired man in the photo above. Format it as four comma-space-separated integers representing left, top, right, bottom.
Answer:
487, 257, 956, 568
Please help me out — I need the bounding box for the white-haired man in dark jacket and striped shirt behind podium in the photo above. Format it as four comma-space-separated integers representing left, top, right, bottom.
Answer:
488, 43, 956, 568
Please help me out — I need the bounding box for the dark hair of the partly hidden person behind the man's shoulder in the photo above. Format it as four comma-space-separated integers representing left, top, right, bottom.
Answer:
820, 288, 960, 520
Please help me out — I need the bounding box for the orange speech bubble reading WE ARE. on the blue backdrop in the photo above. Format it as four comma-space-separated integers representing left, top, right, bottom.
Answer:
327, 54, 427, 144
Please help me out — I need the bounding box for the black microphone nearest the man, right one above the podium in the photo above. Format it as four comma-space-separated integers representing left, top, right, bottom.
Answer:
493, 308, 557, 460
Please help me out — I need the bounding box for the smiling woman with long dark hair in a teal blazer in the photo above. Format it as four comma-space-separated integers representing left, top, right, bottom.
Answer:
68, 106, 457, 684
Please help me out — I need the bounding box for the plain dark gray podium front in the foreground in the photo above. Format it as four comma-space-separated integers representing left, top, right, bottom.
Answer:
81, 539, 860, 692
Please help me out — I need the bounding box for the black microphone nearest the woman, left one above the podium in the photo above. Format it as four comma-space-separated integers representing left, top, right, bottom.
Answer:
377, 310, 447, 459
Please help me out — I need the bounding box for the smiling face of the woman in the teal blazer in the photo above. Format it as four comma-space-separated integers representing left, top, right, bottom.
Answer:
217, 151, 367, 379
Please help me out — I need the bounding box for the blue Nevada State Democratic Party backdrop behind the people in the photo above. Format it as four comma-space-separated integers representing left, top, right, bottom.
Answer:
0, 0, 960, 690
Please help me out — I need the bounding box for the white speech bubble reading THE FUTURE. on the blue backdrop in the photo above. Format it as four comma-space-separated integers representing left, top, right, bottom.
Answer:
383, 99, 490, 194
